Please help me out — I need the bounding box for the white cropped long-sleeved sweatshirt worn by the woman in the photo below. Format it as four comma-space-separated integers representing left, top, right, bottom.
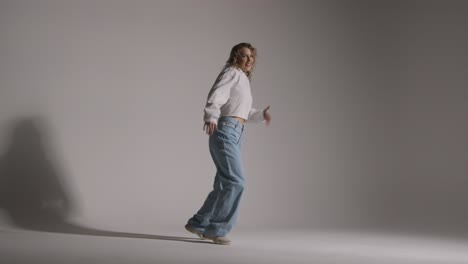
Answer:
203, 66, 265, 123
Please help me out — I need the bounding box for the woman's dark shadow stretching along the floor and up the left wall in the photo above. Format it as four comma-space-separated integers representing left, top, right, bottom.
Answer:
0, 117, 207, 243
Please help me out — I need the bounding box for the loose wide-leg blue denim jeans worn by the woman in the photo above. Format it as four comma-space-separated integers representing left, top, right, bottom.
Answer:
188, 116, 244, 236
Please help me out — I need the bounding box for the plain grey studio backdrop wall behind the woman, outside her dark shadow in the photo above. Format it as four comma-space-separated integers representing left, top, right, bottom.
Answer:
0, 0, 468, 237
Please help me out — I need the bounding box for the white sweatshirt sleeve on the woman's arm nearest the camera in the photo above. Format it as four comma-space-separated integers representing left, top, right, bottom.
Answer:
203, 68, 238, 123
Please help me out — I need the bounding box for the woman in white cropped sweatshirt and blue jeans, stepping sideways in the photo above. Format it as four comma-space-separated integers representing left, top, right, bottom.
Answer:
185, 43, 271, 245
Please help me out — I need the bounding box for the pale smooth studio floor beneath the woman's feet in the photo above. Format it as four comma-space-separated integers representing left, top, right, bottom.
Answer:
0, 224, 468, 264
